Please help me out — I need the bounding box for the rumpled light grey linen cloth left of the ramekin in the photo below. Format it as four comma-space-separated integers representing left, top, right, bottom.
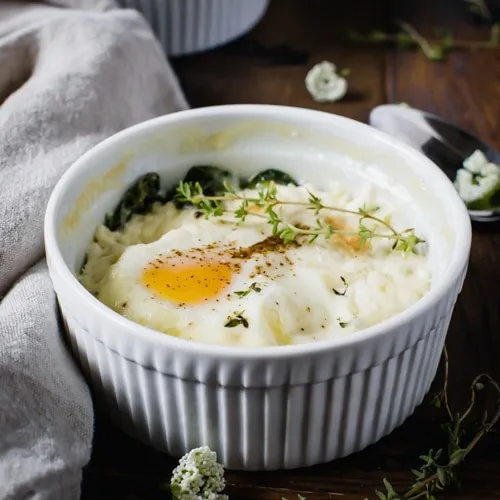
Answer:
0, 0, 187, 500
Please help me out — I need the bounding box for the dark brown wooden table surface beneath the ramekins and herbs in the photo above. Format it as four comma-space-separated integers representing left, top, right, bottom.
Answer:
82, 0, 500, 500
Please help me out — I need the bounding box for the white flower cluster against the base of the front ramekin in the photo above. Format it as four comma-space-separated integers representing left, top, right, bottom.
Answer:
170, 446, 228, 500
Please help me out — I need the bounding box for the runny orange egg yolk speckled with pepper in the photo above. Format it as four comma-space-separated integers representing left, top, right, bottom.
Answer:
142, 258, 234, 305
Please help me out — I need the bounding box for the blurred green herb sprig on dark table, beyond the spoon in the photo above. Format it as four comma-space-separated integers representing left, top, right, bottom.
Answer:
348, 21, 500, 61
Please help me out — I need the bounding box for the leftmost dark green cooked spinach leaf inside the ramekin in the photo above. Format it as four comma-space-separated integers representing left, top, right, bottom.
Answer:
104, 172, 162, 231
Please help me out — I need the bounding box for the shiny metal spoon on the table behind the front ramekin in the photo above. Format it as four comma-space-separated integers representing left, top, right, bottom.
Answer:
369, 104, 500, 222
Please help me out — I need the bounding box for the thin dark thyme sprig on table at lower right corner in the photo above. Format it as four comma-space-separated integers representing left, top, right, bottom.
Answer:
376, 348, 500, 500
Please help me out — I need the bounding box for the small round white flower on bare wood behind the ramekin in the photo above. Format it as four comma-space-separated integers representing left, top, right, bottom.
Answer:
306, 61, 347, 102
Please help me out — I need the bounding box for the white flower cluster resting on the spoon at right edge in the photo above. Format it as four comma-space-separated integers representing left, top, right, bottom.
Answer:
454, 150, 500, 208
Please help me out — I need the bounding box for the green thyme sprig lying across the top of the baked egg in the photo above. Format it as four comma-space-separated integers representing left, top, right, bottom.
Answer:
175, 182, 424, 252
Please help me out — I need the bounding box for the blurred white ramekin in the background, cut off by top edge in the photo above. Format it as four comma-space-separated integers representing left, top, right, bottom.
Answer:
118, 0, 269, 56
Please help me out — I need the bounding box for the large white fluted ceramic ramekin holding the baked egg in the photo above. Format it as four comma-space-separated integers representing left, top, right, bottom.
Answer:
45, 105, 471, 470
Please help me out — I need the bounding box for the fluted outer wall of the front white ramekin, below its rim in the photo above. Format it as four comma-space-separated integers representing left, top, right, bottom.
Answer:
56, 268, 462, 470
